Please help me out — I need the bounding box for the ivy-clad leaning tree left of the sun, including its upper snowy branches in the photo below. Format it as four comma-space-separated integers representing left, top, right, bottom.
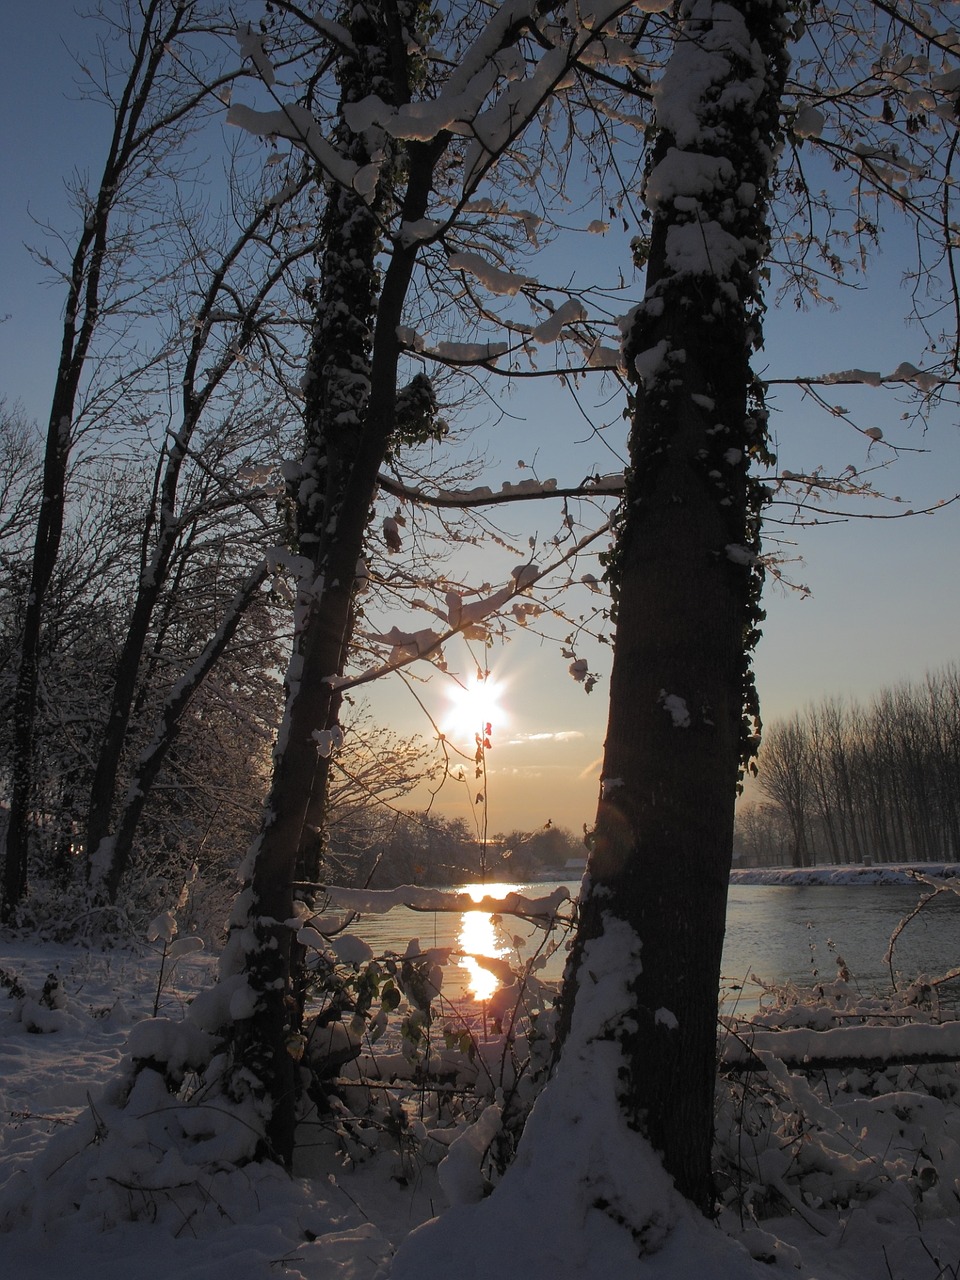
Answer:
221, 0, 655, 1164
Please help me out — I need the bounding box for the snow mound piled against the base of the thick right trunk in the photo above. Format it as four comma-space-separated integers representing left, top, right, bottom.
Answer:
390, 922, 773, 1280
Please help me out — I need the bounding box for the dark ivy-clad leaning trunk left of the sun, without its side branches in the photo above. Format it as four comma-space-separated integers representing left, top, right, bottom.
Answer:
224, 0, 443, 1165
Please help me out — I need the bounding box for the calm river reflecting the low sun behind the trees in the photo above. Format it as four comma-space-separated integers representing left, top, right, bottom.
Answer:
351, 882, 960, 1012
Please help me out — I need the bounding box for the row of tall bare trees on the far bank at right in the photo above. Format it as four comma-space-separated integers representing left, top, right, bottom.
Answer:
739, 664, 960, 867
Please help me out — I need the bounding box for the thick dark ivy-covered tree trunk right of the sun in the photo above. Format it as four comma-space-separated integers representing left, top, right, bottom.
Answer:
562, 0, 786, 1211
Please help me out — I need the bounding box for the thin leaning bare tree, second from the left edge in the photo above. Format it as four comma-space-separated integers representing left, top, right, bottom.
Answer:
86, 175, 314, 900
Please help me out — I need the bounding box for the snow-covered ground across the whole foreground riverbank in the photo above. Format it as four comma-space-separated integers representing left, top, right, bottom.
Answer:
0, 911, 960, 1280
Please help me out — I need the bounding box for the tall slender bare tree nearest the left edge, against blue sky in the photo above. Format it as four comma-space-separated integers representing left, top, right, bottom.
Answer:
3, 0, 248, 918
